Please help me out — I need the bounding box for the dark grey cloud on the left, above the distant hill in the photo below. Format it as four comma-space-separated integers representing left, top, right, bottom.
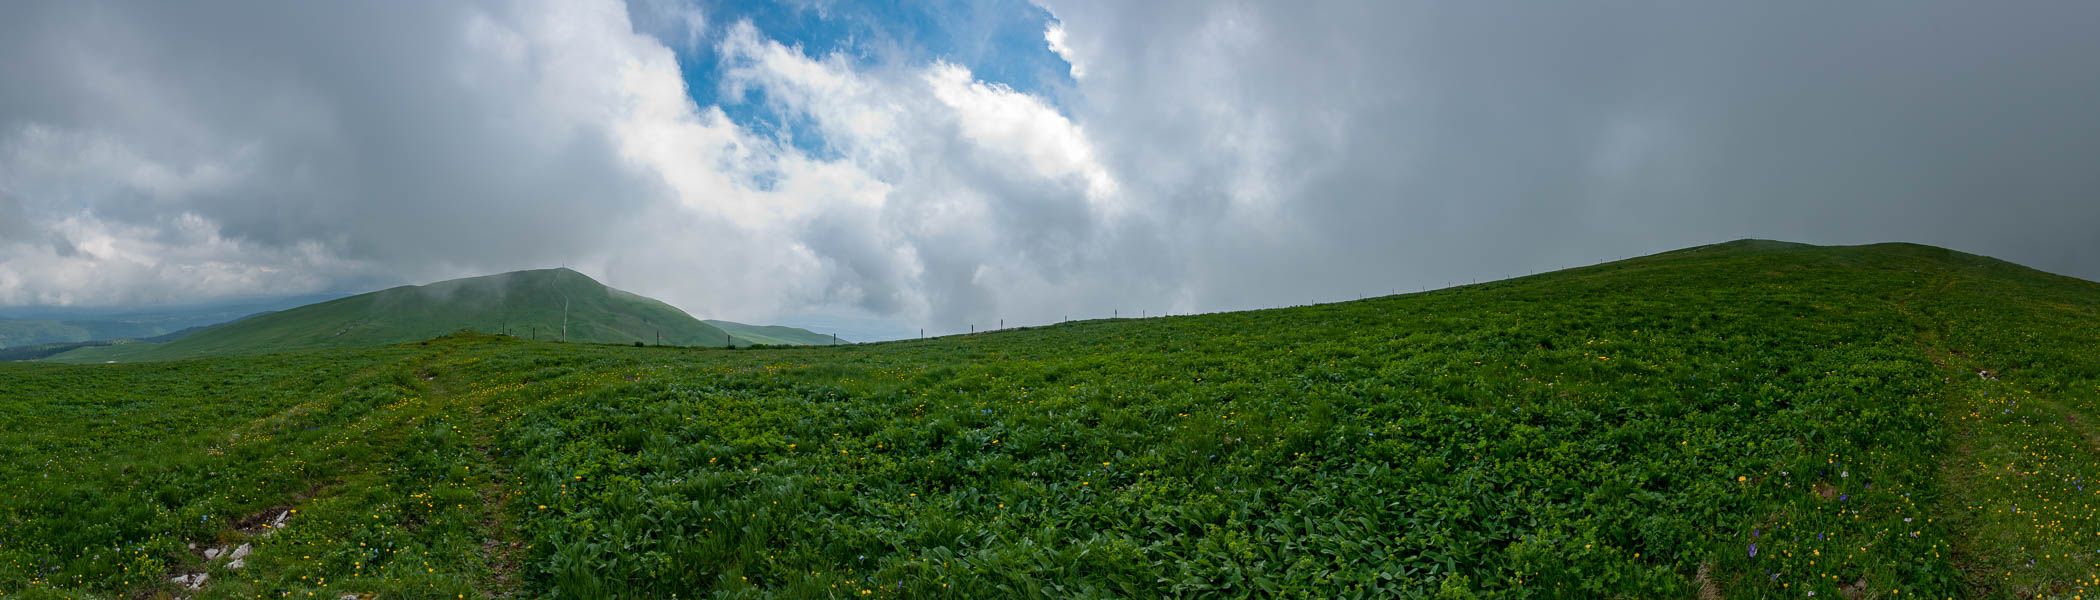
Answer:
0, 2, 663, 277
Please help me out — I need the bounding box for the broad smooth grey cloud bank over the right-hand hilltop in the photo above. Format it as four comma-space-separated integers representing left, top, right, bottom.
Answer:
1050, 2, 2100, 314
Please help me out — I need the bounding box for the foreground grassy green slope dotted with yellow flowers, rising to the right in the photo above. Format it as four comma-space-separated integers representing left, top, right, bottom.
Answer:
0, 241, 2100, 600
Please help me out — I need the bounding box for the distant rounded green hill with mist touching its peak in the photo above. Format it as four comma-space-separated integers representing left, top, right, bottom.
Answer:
46, 269, 731, 363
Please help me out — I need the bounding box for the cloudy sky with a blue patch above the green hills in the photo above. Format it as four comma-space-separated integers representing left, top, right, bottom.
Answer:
0, 0, 2100, 338
